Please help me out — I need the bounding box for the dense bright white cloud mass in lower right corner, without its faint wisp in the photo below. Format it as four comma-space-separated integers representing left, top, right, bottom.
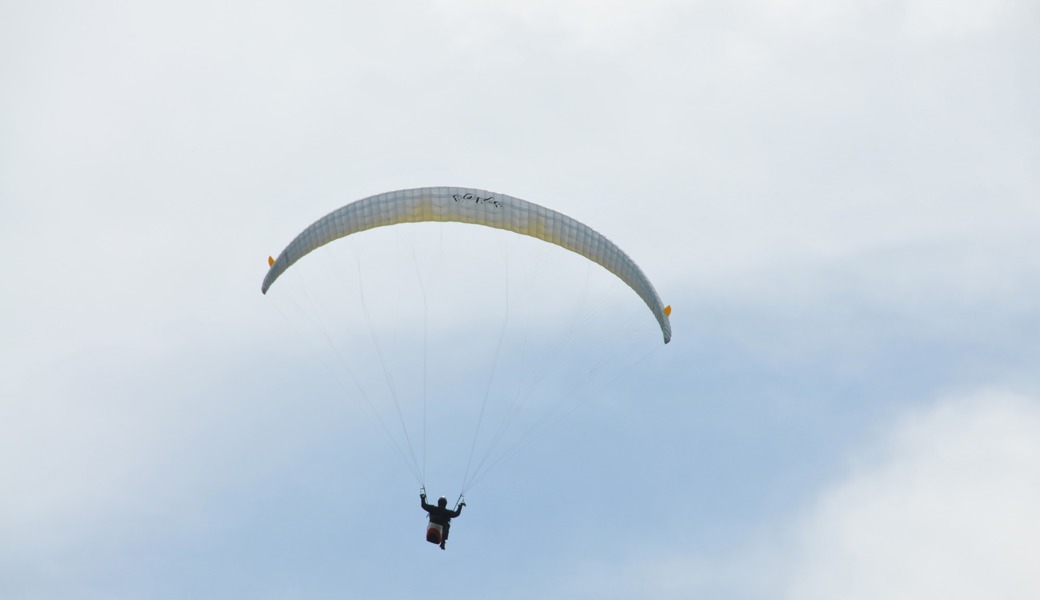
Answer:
788, 392, 1040, 600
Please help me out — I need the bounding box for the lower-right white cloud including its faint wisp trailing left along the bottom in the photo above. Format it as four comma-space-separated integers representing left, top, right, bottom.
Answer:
565, 391, 1040, 600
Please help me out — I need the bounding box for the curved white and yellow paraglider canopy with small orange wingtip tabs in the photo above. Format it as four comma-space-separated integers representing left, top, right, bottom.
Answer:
261, 187, 672, 343
